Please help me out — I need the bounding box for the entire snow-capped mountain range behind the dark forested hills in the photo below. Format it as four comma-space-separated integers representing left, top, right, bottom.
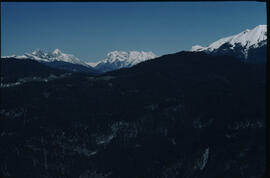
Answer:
2, 25, 267, 74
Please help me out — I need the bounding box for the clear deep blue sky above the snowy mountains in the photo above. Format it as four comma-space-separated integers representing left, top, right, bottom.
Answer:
1, 2, 266, 62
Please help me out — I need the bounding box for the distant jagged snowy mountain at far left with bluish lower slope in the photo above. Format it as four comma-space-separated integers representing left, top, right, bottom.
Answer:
2, 49, 99, 73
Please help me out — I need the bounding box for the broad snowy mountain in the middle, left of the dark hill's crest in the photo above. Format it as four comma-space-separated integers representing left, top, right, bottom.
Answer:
92, 51, 157, 72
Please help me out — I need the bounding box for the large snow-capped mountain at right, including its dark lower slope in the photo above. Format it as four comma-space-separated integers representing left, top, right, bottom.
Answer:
191, 25, 267, 63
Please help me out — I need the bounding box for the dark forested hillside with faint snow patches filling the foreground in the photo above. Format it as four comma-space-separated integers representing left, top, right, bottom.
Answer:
0, 52, 266, 178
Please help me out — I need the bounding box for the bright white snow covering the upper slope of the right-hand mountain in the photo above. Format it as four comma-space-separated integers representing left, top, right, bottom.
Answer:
190, 25, 267, 57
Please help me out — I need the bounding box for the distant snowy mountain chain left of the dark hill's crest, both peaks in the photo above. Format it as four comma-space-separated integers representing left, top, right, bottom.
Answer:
2, 49, 157, 73
